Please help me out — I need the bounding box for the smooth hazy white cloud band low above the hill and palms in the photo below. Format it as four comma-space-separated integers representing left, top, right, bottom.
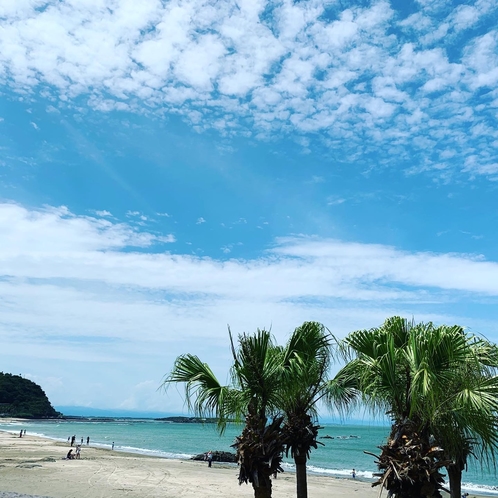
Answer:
0, 203, 498, 411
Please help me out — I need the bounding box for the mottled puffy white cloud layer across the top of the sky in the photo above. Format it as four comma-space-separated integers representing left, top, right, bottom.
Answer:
0, 0, 498, 179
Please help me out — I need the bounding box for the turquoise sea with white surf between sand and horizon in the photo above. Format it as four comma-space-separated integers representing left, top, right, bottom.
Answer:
0, 419, 498, 496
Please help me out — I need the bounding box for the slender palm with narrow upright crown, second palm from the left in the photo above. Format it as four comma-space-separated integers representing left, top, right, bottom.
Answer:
279, 322, 332, 498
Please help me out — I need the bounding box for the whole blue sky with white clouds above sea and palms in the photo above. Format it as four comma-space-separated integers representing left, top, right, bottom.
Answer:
0, 0, 498, 413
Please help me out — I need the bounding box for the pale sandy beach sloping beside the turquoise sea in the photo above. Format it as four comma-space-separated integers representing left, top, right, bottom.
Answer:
0, 432, 379, 498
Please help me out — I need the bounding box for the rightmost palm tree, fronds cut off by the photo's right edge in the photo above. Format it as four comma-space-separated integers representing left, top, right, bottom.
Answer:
431, 326, 498, 498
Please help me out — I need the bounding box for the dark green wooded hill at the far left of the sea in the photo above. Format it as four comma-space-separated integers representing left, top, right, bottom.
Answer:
0, 372, 61, 418
